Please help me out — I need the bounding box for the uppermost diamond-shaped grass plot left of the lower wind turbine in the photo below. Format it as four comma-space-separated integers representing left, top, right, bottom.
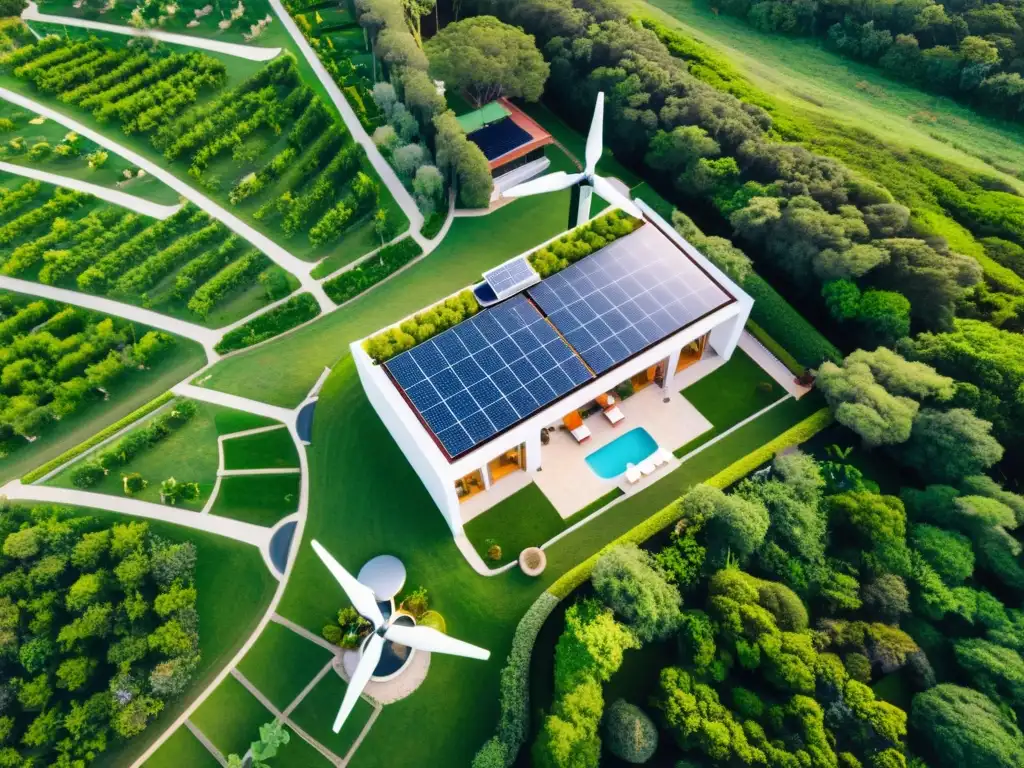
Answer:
239, 622, 332, 710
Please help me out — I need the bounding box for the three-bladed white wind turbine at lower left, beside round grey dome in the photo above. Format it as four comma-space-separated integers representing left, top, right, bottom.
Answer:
310, 541, 490, 733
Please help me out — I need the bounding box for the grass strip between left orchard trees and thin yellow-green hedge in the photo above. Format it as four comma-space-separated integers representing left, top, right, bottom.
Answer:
0, 337, 206, 483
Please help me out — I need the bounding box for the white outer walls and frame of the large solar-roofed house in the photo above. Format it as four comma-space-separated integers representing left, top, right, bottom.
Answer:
351, 200, 754, 536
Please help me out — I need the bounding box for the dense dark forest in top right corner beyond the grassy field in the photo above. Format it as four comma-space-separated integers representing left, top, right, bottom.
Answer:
711, 0, 1024, 121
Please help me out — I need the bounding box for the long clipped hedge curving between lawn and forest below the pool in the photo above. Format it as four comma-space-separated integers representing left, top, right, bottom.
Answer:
473, 408, 833, 768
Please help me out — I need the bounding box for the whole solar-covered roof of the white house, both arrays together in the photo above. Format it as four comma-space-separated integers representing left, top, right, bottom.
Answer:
383, 222, 735, 461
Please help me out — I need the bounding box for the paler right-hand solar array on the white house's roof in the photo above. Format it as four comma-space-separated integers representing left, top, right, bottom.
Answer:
527, 224, 730, 374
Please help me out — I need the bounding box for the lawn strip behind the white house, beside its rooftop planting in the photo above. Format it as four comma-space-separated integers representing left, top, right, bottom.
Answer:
197, 152, 585, 408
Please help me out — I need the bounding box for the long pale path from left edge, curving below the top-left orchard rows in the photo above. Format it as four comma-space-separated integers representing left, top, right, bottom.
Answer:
0, 88, 331, 312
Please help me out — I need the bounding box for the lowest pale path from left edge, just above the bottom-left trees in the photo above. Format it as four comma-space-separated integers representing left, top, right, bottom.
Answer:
2, 480, 270, 551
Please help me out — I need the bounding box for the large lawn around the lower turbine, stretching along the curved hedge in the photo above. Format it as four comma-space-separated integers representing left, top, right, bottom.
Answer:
278, 359, 820, 768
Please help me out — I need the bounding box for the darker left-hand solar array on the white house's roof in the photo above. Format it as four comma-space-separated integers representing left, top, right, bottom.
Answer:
384, 295, 594, 459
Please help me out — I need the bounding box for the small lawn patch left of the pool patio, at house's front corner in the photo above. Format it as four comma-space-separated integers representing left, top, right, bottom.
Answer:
466, 482, 565, 567
